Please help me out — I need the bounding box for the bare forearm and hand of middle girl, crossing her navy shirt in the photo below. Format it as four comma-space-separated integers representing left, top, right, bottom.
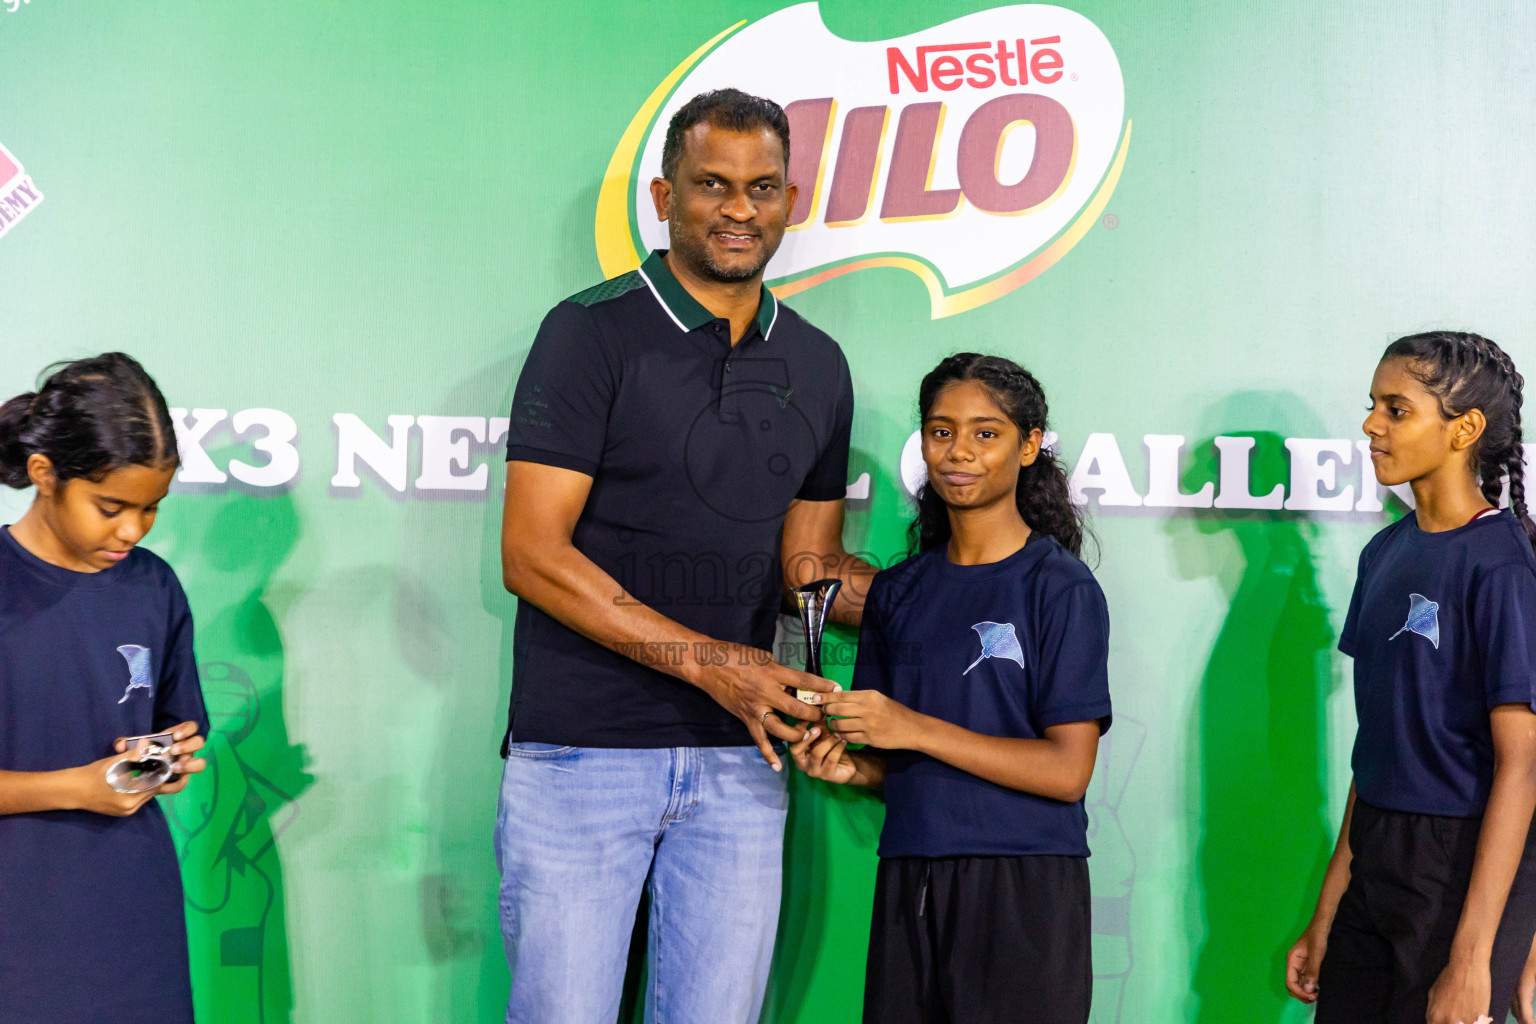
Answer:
823, 689, 1098, 803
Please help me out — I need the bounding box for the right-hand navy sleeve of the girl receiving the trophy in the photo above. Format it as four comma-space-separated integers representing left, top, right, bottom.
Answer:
1034, 580, 1111, 732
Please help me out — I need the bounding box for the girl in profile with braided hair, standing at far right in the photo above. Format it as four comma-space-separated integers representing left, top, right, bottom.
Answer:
1286, 332, 1536, 1024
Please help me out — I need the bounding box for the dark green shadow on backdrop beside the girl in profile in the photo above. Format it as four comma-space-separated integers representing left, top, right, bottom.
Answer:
1167, 393, 1336, 1024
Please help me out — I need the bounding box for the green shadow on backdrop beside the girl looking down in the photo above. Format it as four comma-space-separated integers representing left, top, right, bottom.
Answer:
166, 493, 313, 1024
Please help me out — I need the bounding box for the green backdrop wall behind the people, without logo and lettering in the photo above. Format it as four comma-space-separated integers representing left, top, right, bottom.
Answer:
0, 0, 1536, 1024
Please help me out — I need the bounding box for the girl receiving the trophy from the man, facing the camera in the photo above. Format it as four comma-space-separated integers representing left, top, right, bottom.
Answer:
791, 353, 1111, 1024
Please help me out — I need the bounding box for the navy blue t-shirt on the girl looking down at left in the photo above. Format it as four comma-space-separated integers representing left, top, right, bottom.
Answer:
0, 527, 207, 1024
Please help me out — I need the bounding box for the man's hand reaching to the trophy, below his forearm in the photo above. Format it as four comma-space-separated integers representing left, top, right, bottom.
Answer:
699, 643, 842, 772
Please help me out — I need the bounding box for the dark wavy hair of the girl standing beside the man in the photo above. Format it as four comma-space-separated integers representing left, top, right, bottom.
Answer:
908, 352, 1083, 557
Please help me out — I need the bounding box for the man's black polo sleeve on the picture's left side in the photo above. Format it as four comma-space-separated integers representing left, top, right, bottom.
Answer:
507, 302, 617, 476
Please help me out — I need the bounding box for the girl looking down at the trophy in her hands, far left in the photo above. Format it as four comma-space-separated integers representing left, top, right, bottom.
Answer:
0, 353, 207, 1024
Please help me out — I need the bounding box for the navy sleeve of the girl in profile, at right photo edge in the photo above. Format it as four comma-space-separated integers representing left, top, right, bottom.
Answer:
1471, 562, 1536, 709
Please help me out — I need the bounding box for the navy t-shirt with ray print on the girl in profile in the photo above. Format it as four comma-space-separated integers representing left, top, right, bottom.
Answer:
1339, 511, 1536, 818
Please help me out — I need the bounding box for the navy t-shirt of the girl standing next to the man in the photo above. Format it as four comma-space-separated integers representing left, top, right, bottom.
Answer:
854, 533, 1111, 857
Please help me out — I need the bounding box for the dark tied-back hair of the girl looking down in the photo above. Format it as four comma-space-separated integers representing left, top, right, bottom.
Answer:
0, 352, 180, 488
